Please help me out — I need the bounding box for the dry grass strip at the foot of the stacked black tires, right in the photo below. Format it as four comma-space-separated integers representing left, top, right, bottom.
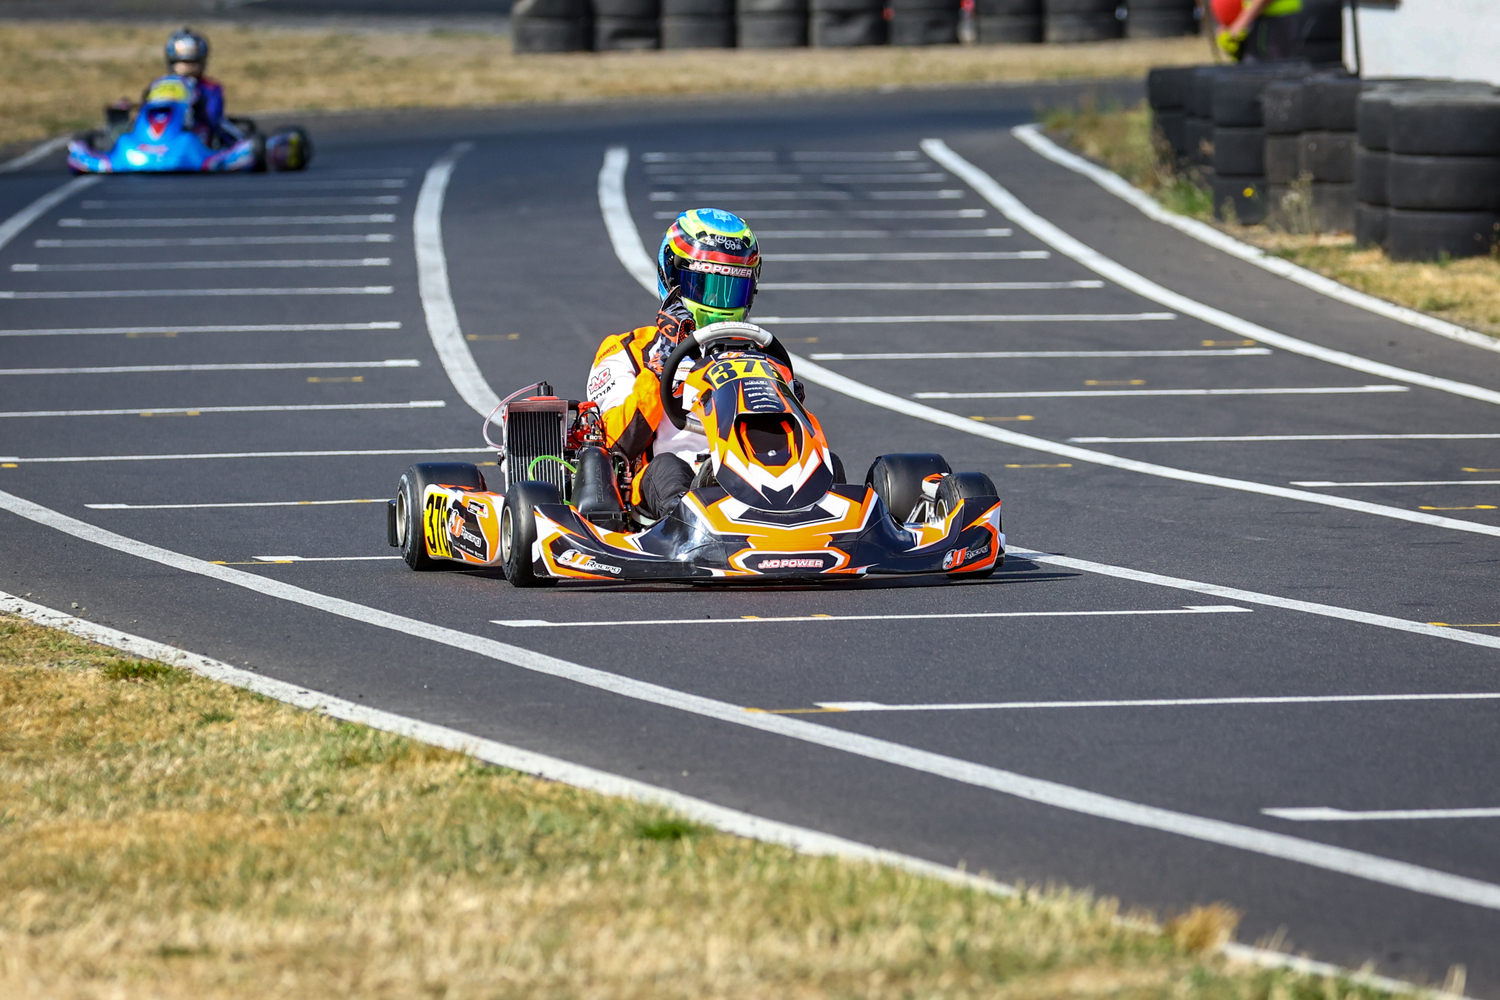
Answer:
1044, 100, 1500, 336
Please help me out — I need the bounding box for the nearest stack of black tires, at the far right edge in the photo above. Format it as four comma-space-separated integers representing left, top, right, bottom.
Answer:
1355, 81, 1500, 261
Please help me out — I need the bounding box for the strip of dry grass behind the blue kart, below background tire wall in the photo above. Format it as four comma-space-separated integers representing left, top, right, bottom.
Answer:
0, 21, 1203, 145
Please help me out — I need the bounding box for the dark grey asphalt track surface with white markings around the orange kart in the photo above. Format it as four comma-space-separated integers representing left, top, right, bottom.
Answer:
0, 88, 1500, 996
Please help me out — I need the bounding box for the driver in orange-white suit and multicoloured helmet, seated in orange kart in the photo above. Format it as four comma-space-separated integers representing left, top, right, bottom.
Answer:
588, 208, 761, 519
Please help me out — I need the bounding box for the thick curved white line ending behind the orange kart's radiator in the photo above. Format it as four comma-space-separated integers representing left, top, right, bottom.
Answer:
411, 142, 500, 417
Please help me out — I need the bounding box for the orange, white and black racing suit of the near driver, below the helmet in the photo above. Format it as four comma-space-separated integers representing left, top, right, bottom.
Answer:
587, 306, 708, 517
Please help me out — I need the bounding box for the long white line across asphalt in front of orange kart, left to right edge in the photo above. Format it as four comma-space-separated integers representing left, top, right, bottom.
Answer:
0, 492, 1500, 910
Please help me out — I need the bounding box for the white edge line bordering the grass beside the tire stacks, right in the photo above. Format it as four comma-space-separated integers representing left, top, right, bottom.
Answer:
1011, 124, 1500, 351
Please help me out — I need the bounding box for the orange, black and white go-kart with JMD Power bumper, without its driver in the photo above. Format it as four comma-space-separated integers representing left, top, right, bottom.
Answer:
387, 322, 1005, 586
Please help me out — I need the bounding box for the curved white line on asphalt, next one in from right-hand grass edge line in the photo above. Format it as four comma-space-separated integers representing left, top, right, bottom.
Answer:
923, 139, 1500, 403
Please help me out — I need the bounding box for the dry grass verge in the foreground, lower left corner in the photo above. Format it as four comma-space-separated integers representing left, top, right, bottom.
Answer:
0, 616, 1404, 1000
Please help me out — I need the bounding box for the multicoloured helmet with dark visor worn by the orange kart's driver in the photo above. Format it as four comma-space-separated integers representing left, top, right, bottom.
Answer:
657, 208, 761, 327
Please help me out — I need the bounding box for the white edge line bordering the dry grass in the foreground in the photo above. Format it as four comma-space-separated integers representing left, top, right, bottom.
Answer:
0, 591, 1470, 1000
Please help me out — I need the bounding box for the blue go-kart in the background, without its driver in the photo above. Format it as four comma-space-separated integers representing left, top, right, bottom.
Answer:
68, 76, 312, 174
